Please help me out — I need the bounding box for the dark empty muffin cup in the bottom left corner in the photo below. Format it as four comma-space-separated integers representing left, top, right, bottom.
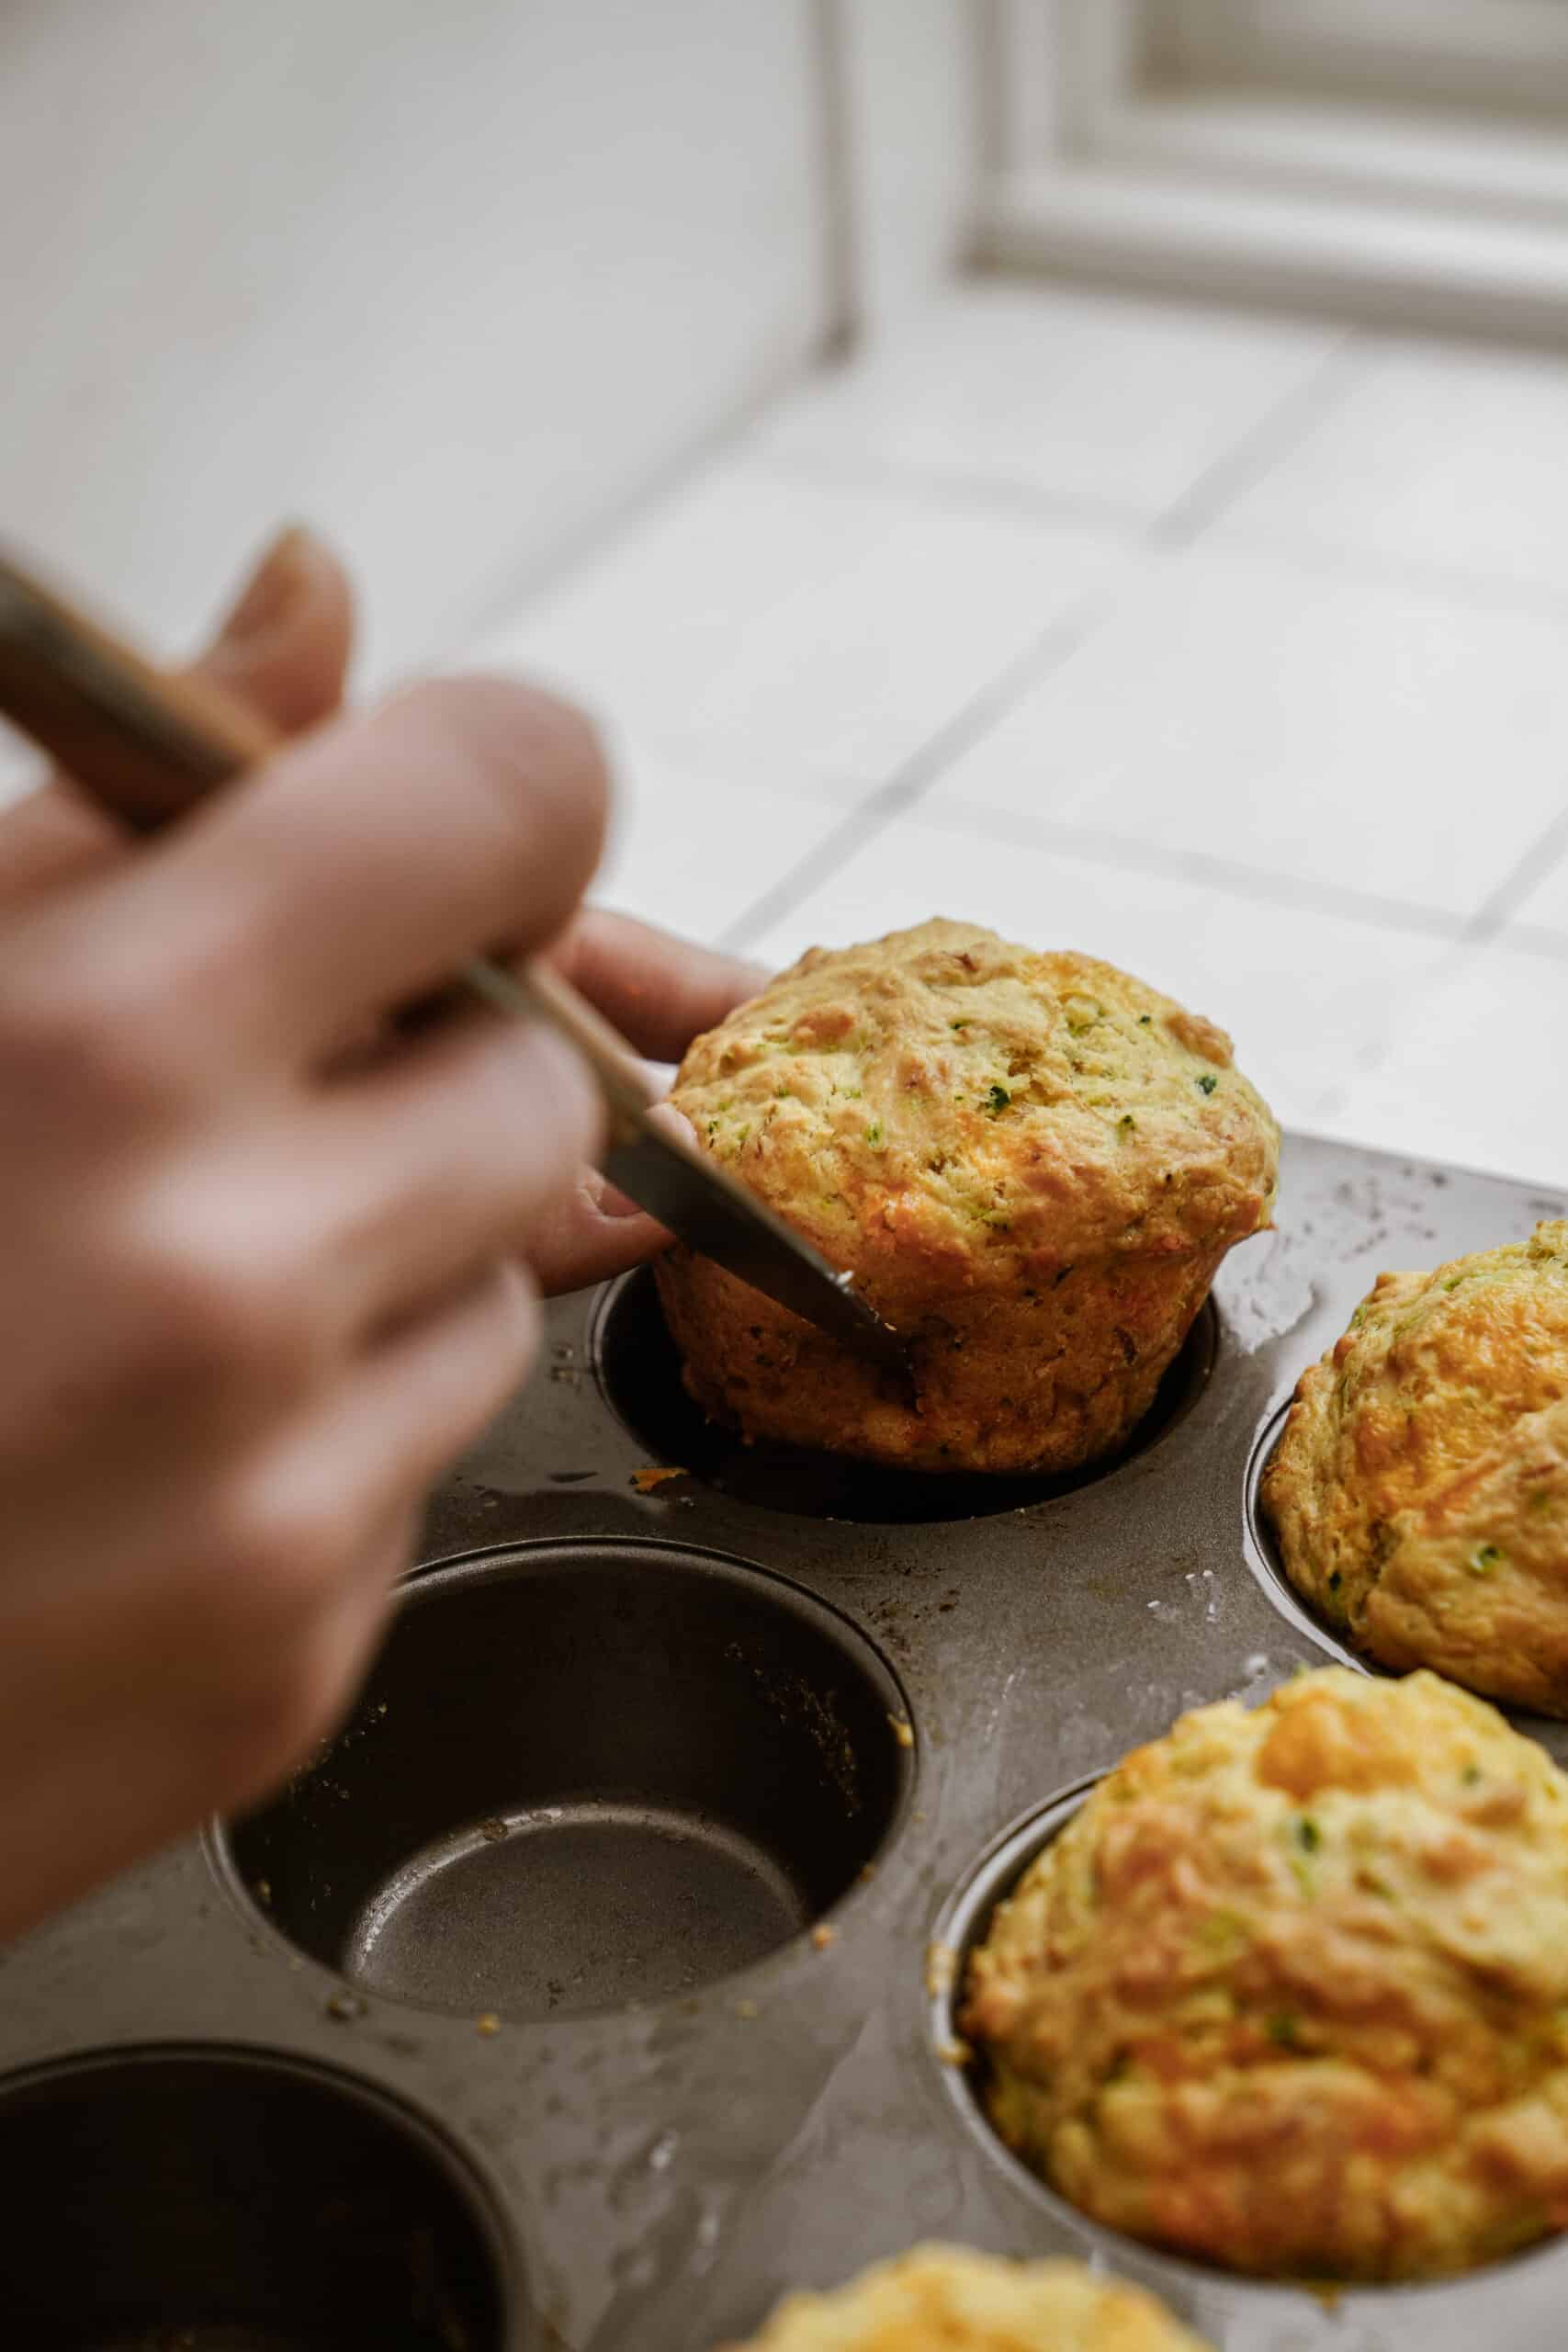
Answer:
0, 2046, 520, 2352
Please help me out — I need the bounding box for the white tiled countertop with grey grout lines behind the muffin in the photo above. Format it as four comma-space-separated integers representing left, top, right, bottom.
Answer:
478, 282, 1568, 1183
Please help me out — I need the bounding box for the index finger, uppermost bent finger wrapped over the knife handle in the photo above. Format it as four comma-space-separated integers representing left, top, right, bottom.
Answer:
94, 677, 606, 1051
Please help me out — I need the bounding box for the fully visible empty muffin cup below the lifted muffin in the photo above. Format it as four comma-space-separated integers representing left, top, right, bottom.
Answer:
221, 1541, 915, 2018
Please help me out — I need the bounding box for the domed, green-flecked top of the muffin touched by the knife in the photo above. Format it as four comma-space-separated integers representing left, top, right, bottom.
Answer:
674, 920, 1279, 1303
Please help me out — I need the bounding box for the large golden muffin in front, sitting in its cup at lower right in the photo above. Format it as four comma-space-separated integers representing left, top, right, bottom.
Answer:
962, 1668, 1568, 2279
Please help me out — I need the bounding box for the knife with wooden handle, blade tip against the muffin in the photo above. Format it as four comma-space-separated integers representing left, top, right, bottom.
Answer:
0, 550, 909, 1383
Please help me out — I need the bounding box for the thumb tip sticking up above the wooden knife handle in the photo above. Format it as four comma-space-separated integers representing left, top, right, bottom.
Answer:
193, 525, 355, 734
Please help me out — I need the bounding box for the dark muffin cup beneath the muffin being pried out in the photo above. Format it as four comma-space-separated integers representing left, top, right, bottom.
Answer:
592, 1268, 1220, 1526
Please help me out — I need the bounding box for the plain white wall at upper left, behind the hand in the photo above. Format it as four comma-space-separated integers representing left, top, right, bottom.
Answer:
0, 0, 825, 675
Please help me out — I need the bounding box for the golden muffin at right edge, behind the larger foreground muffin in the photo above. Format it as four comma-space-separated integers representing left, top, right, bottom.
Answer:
1262, 1221, 1568, 1714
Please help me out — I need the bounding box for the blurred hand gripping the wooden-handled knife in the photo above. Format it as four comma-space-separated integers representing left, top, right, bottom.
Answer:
0, 541, 625, 1933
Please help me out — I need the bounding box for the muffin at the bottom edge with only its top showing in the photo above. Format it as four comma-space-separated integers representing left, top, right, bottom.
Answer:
731, 2246, 1206, 2352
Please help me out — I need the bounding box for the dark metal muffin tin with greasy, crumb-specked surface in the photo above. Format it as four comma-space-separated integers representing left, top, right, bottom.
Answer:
0, 1141, 1568, 2352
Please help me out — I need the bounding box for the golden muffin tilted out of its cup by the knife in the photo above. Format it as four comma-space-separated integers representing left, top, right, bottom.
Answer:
659, 922, 1279, 1473
